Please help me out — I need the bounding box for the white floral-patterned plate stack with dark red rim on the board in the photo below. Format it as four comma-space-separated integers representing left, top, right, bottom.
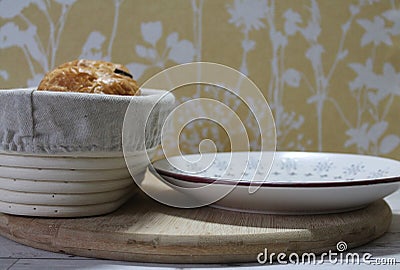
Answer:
153, 152, 400, 214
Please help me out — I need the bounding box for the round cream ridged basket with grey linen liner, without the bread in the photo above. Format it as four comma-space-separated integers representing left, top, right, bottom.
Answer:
0, 88, 175, 217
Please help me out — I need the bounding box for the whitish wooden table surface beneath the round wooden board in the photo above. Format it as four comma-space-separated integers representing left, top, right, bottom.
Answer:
0, 191, 400, 270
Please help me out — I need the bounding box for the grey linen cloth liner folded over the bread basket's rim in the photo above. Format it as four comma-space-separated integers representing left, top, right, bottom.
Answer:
0, 88, 174, 154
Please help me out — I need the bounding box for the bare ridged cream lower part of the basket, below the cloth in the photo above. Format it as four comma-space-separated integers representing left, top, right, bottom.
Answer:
0, 150, 154, 217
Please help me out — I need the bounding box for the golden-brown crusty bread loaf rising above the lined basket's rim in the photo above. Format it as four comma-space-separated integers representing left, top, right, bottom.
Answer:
38, 59, 140, 95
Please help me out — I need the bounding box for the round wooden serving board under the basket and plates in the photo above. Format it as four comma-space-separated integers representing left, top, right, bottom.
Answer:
0, 177, 392, 263
